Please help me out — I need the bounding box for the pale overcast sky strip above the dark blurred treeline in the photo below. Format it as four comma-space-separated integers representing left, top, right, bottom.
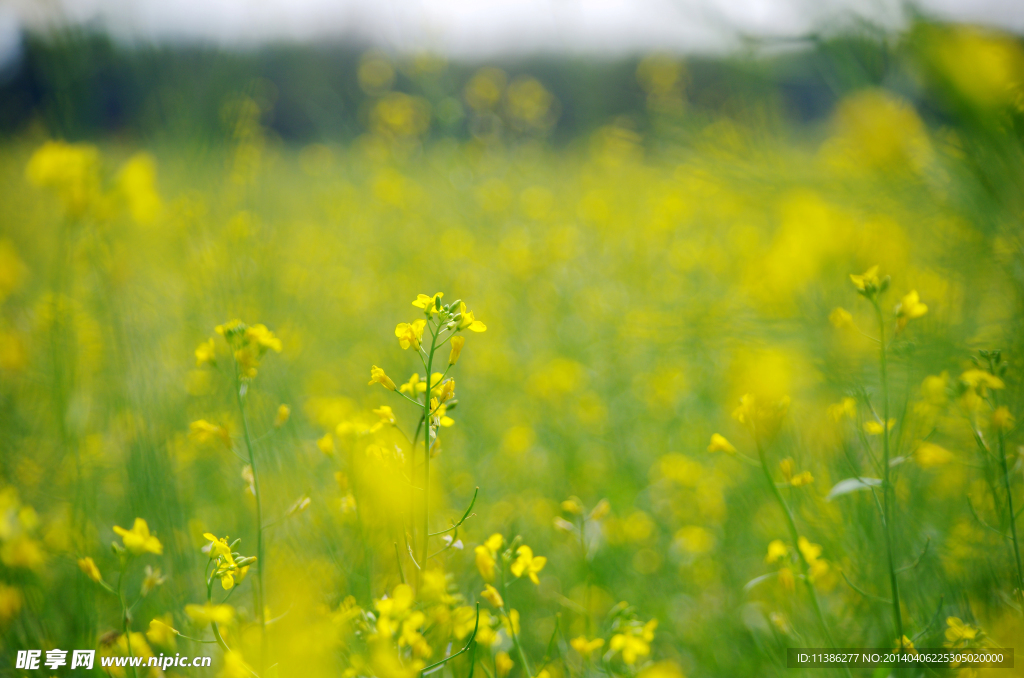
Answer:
0, 0, 1024, 66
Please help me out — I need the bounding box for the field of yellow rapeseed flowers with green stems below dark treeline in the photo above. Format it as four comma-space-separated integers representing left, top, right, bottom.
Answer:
0, 21, 1024, 678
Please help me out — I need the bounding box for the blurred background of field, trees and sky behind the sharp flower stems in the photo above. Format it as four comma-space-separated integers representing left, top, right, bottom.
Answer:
0, 0, 1024, 678
